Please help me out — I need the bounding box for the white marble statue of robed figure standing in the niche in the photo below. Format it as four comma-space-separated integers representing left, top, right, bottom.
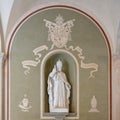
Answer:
48, 60, 71, 112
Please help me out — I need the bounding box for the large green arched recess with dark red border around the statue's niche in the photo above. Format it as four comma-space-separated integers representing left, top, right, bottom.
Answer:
6, 6, 112, 120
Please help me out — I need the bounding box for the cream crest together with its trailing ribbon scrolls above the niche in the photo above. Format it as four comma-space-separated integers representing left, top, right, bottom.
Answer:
22, 14, 98, 78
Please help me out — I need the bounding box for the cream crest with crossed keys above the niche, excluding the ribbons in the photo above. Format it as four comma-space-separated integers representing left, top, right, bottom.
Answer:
44, 15, 75, 48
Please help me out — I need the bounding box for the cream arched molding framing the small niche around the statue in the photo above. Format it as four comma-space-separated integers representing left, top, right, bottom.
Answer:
40, 49, 80, 119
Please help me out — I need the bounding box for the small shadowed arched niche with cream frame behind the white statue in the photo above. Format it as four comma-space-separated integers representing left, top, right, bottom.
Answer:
40, 50, 80, 116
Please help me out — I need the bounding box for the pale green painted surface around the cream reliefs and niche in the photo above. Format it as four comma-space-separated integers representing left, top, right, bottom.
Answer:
10, 8, 110, 120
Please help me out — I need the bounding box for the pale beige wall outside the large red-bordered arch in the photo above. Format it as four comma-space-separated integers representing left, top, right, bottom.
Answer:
0, 0, 120, 120
